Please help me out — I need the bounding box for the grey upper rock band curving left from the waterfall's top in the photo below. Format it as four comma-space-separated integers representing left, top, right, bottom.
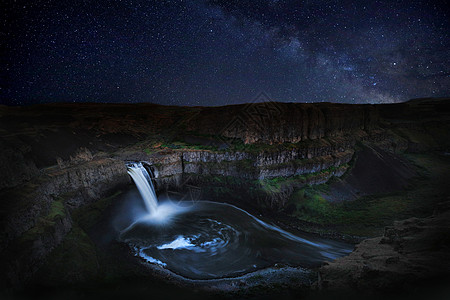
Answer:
3, 159, 130, 240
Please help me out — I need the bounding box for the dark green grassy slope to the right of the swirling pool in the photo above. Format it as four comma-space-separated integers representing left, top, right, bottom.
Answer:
290, 154, 450, 236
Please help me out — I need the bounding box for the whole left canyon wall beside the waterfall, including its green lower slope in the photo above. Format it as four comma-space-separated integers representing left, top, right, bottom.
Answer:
0, 159, 130, 285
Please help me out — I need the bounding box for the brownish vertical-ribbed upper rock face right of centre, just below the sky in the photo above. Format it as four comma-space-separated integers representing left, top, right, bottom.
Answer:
187, 102, 378, 144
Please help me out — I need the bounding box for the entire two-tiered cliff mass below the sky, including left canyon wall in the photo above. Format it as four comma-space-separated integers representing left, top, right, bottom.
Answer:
0, 100, 450, 292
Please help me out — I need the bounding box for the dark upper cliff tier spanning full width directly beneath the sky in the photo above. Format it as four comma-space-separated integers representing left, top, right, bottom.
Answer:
0, 99, 449, 189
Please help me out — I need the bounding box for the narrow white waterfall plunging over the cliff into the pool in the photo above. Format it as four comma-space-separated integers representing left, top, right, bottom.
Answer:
127, 162, 158, 214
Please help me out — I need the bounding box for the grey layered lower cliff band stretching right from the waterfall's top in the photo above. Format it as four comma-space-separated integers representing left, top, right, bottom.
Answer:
116, 141, 354, 209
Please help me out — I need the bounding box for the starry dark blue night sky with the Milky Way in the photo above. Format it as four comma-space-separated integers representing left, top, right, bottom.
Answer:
0, 0, 450, 105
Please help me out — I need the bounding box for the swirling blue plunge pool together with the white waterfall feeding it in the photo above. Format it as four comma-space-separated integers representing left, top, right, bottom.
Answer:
124, 165, 352, 279
